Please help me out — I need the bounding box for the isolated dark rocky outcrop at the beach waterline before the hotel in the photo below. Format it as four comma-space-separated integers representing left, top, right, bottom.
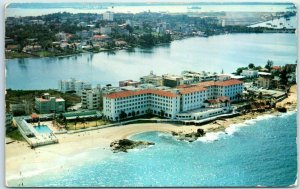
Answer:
110, 139, 155, 152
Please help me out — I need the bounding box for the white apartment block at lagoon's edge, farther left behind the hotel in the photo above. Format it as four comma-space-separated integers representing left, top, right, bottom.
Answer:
58, 78, 92, 96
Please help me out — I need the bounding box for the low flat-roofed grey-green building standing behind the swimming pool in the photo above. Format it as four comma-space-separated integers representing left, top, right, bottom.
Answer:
35, 93, 65, 114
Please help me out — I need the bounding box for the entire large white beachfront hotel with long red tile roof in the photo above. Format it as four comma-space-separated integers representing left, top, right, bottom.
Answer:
103, 79, 243, 121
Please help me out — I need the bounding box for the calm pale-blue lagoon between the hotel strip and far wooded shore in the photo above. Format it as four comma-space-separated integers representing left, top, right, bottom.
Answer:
6, 34, 297, 89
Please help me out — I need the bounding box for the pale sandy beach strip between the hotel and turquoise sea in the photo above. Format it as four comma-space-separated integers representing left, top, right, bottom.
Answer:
5, 85, 297, 183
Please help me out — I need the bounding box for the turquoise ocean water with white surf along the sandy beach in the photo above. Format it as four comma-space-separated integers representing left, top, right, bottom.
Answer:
8, 112, 297, 187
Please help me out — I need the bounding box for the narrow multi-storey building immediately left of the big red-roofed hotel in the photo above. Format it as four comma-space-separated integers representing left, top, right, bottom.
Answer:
81, 88, 102, 110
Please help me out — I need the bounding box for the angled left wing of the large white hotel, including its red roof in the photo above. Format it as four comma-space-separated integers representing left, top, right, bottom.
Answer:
103, 89, 180, 121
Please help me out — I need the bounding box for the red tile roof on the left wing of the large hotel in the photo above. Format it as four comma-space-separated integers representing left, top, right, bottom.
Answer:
105, 89, 179, 98
